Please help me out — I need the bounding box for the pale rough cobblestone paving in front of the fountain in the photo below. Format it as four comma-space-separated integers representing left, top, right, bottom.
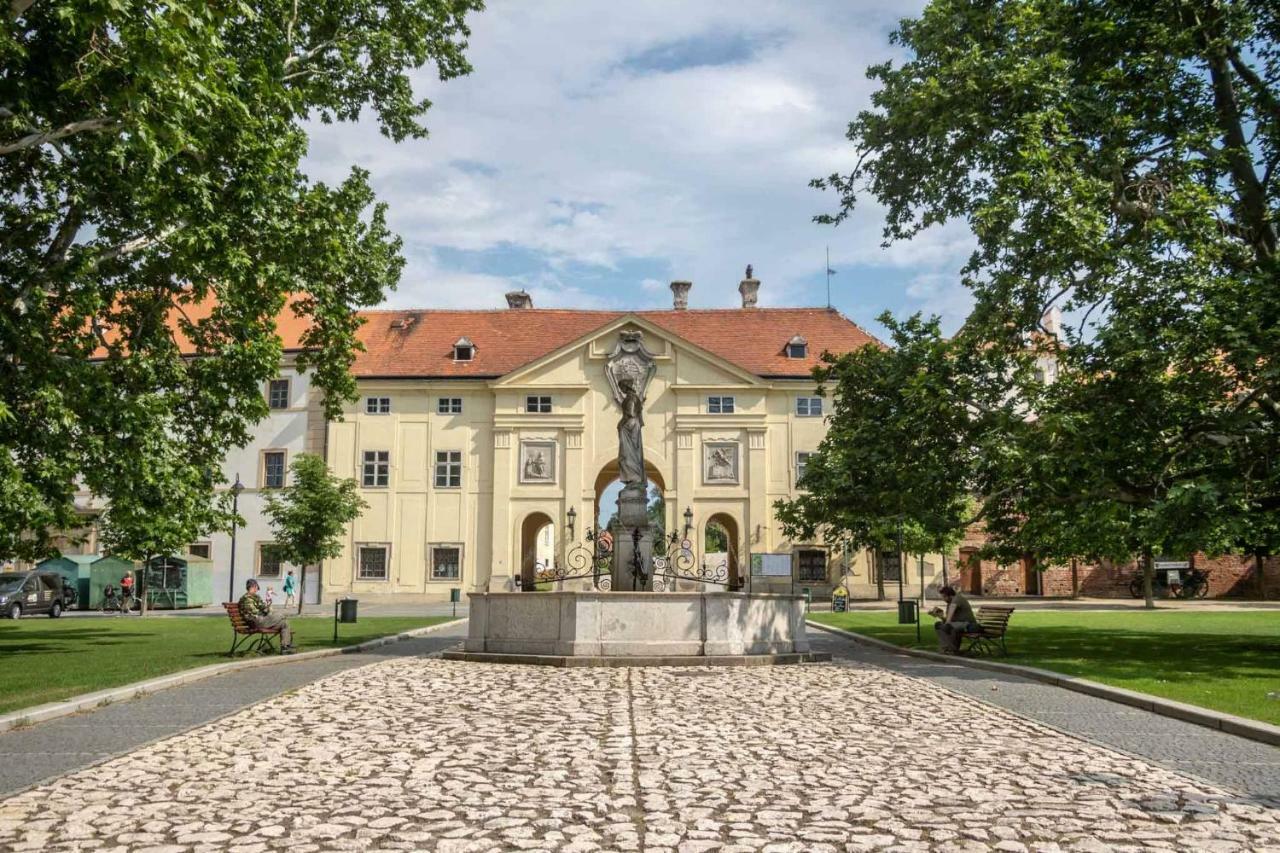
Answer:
0, 658, 1280, 853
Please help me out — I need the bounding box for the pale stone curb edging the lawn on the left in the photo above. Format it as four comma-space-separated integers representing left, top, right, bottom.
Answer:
0, 617, 467, 731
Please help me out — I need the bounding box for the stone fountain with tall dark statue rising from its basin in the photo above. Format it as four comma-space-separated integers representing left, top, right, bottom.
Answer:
444, 332, 829, 666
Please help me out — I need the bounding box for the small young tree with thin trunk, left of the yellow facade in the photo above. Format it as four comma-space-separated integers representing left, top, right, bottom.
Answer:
266, 453, 367, 613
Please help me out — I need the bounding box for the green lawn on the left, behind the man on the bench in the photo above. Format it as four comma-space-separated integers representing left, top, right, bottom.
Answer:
0, 616, 448, 713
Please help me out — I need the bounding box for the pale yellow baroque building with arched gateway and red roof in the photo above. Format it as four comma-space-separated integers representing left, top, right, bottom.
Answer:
321, 277, 914, 601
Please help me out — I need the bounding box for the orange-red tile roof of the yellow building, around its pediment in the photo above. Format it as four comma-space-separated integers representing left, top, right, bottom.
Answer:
352, 302, 878, 378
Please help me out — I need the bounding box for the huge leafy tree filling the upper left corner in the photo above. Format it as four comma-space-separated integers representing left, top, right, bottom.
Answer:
0, 0, 480, 557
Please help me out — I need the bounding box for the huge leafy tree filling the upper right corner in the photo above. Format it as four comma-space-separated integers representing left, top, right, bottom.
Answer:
814, 0, 1280, 601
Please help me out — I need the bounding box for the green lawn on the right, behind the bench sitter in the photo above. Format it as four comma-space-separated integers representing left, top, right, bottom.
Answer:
810, 611, 1280, 725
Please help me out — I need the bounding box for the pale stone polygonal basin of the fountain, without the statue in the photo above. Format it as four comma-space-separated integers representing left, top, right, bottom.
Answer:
445, 590, 814, 665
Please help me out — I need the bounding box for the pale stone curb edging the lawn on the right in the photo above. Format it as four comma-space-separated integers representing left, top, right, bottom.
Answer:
805, 620, 1280, 747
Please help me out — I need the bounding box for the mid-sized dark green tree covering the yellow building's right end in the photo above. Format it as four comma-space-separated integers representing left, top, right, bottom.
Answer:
774, 314, 1019, 596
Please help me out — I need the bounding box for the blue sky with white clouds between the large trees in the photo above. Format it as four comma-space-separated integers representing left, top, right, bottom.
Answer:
306, 0, 973, 332
